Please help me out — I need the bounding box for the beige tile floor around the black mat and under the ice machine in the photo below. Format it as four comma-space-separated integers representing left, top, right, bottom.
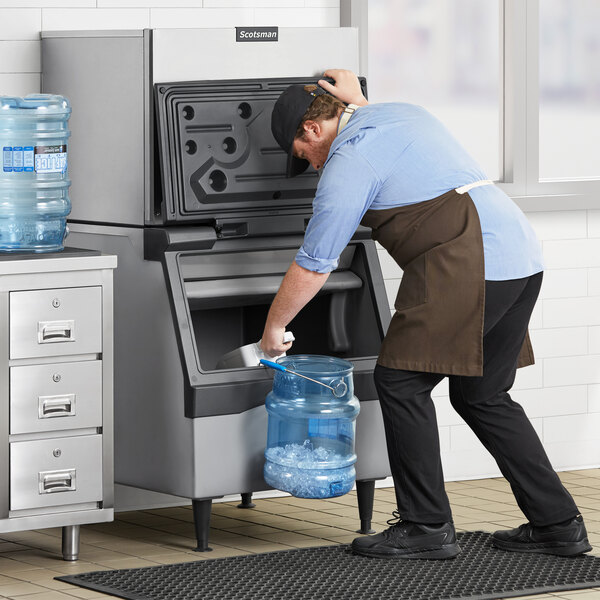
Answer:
0, 469, 600, 600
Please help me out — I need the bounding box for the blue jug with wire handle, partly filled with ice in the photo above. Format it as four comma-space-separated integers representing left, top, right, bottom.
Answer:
264, 355, 360, 498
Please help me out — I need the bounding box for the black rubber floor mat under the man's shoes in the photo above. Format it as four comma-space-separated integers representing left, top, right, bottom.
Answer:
56, 531, 600, 600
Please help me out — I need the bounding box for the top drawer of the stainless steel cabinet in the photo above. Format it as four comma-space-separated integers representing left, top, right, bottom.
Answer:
10, 286, 102, 358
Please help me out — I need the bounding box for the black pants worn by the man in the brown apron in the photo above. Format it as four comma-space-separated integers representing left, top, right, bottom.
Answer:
375, 273, 579, 526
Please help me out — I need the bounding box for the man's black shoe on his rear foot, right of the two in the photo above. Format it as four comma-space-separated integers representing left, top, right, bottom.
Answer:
492, 515, 592, 556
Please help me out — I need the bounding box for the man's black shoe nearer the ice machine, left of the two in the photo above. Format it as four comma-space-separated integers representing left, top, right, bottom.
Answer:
352, 511, 460, 559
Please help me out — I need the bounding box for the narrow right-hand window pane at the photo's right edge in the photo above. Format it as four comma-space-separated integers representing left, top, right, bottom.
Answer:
539, 0, 600, 180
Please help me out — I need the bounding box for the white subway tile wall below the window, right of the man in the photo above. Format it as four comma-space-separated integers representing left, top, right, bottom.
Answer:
524, 210, 600, 469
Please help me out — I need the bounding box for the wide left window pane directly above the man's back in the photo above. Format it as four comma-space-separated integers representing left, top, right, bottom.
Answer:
368, 0, 501, 179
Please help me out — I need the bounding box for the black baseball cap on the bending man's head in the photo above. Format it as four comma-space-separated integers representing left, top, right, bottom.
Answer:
271, 84, 327, 177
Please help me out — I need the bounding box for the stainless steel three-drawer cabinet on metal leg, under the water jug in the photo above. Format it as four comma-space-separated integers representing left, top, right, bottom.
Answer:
0, 248, 116, 560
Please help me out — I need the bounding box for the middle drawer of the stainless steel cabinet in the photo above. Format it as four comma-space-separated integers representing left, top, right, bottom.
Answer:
10, 360, 102, 434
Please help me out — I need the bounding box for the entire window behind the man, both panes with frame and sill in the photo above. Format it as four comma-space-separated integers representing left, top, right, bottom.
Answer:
340, 0, 600, 210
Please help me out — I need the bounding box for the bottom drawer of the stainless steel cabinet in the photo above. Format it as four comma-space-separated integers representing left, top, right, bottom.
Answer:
10, 435, 102, 510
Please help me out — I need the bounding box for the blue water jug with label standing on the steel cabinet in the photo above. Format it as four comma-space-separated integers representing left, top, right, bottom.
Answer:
0, 94, 71, 252
